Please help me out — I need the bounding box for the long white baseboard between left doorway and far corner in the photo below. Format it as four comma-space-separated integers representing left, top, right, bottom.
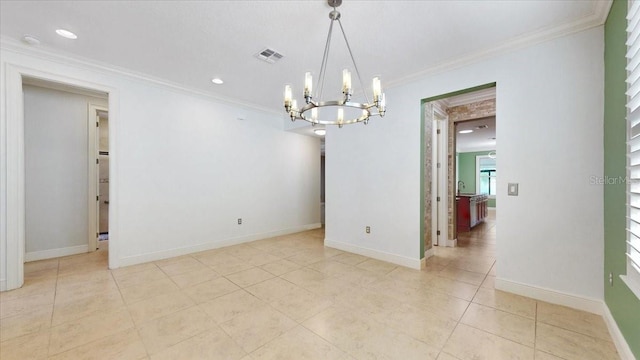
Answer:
119, 223, 322, 267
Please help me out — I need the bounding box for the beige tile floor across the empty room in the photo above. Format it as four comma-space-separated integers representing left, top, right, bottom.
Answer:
0, 211, 618, 360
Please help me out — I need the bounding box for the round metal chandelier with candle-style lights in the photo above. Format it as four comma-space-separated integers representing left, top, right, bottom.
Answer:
284, 0, 386, 127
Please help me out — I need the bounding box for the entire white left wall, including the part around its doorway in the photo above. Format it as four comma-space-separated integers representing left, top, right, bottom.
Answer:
0, 43, 320, 288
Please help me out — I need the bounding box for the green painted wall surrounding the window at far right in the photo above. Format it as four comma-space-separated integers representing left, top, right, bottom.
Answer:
603, 0, 640, 358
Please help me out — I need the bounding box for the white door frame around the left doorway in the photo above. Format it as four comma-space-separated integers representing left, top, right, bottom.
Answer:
0, 63, 119, 290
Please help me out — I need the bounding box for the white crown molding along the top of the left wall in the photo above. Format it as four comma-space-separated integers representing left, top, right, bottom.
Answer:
0, 35, 282, 117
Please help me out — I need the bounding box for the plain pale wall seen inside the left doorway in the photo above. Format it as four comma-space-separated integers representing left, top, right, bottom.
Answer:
23, 85, 107, 259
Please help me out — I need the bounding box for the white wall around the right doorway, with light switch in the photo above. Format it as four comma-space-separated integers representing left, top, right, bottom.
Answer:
326, 27, 604, 299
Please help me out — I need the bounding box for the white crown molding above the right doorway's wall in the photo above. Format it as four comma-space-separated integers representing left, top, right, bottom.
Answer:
385, 0, 613, 89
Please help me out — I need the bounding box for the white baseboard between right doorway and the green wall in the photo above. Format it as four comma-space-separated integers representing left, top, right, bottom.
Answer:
495, 278, 603, 315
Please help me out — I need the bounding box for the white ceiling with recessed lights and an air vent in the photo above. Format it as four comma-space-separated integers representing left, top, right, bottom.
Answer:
0, 0, 611, 129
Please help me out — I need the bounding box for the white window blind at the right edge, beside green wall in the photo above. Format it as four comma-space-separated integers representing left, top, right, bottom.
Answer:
622, 0, 640, 298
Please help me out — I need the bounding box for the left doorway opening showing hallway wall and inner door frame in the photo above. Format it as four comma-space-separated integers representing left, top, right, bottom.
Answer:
22, 77, 109, 262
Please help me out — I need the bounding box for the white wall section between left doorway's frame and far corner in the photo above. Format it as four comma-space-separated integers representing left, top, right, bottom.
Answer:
115, 86, 320, 259
